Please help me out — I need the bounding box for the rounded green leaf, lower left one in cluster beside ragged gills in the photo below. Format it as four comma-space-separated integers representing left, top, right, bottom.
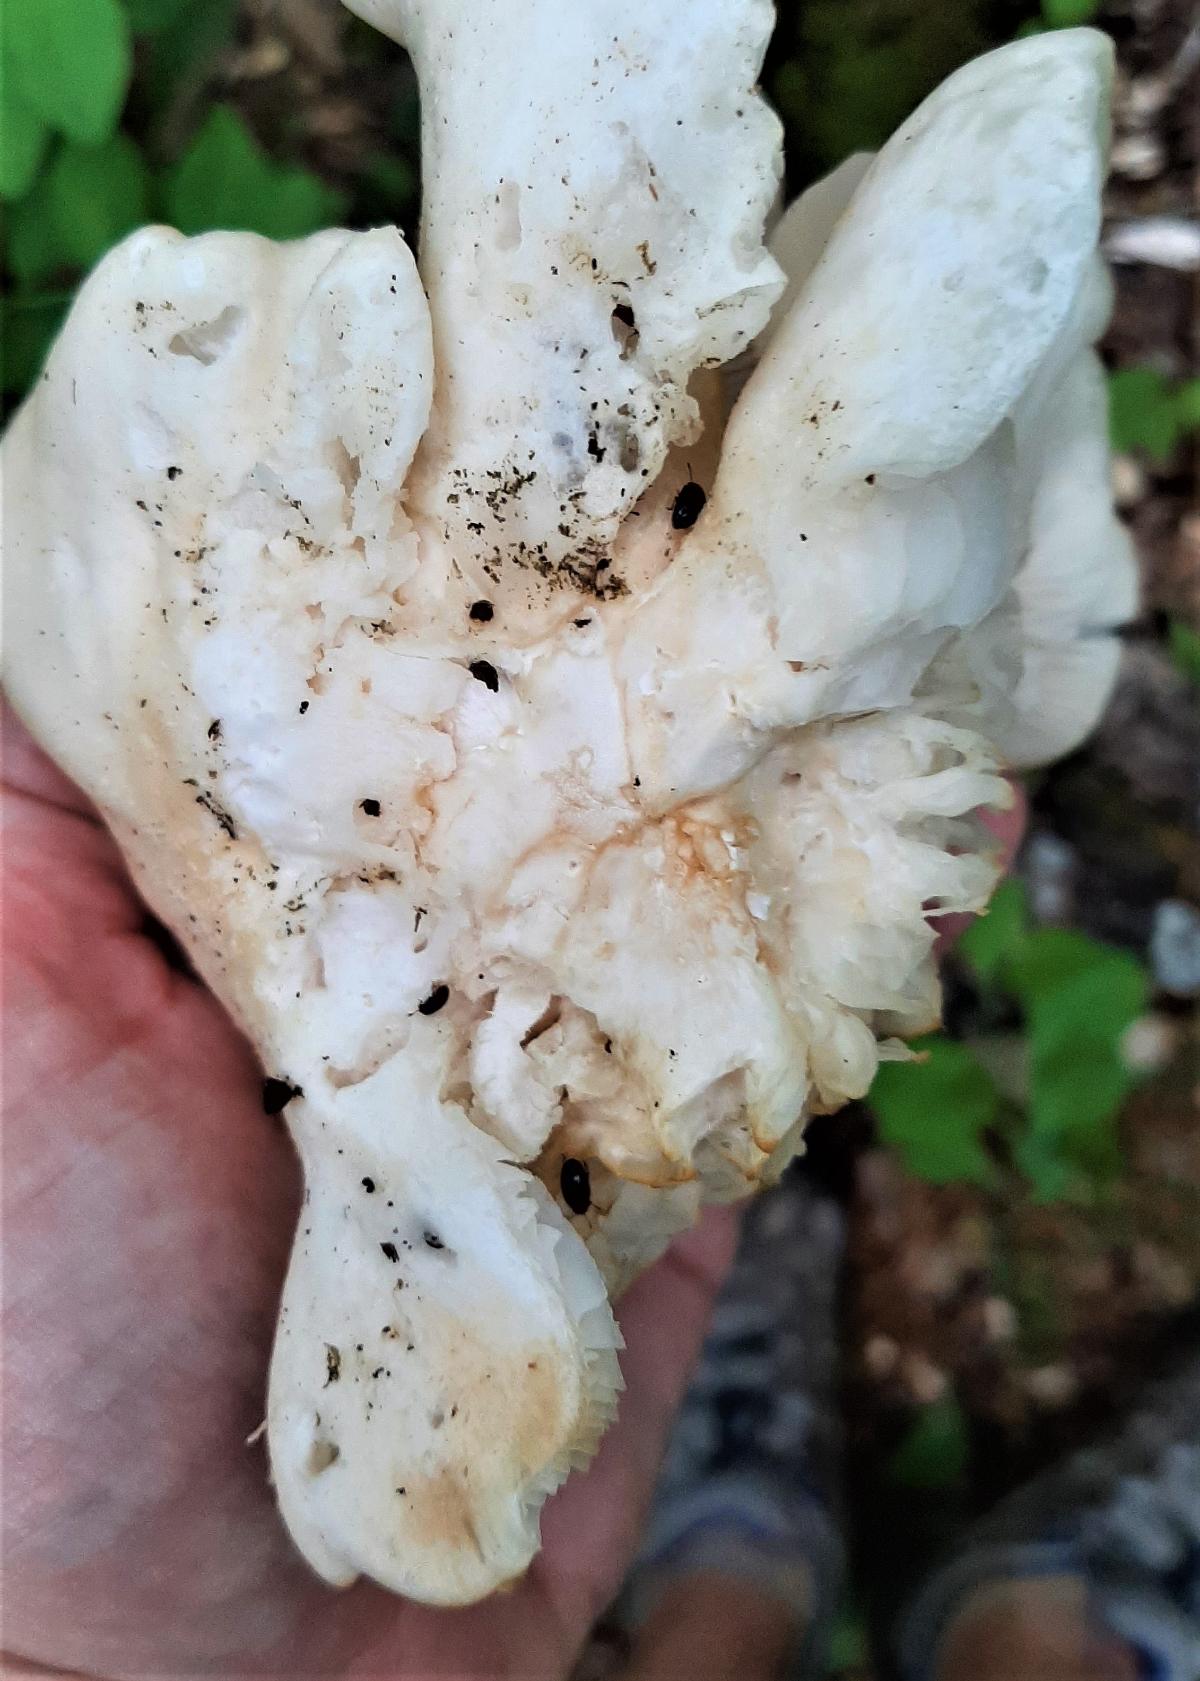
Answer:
869, 1039, 1000, 1185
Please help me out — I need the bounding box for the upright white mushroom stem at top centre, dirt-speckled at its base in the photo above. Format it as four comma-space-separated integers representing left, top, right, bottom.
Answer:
342, 0, 783, 634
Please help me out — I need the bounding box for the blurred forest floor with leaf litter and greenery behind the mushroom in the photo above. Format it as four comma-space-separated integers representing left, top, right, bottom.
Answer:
0, 0, 1200, 1678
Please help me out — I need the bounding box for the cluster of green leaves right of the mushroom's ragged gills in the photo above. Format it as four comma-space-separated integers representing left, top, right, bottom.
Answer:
871, 874, 1149, 1200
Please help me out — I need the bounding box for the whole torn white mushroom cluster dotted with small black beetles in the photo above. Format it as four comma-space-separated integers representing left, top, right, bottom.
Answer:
3, 0, 1134, 1604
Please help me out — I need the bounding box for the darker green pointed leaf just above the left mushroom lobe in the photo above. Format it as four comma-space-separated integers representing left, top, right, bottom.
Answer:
166, 106, 343, 239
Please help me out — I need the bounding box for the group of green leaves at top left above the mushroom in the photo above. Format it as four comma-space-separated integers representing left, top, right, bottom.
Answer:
0, 0, 351, 393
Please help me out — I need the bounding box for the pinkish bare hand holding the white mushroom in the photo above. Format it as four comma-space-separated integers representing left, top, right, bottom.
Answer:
2, 718, 1021, 1681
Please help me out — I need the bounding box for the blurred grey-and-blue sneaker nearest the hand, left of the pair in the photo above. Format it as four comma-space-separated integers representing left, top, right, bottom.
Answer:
620, 1168, 845, 1674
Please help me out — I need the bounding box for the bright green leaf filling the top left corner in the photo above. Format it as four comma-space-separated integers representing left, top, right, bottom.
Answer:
0, 0, 133, 146
